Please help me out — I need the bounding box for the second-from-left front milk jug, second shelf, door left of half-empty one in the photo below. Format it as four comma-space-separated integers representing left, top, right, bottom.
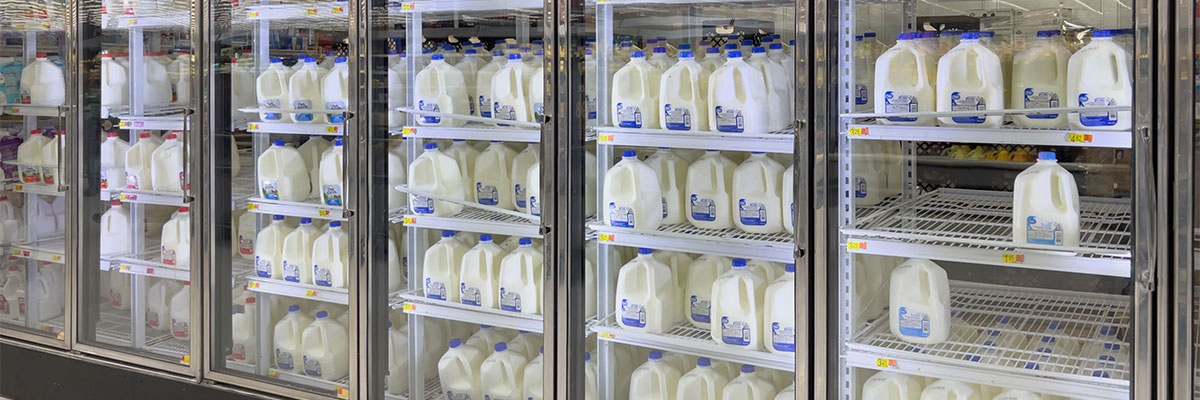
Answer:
685, 149, 737, 229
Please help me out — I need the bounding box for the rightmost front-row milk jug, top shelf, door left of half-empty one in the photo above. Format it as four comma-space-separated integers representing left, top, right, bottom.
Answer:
708, 50, 770, 133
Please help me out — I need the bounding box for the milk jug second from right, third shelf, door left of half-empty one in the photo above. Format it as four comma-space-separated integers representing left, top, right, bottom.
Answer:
709, 258, 767, 350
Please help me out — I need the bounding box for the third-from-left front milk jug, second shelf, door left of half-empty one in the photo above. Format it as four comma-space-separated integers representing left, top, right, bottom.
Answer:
732, 151, 784, 233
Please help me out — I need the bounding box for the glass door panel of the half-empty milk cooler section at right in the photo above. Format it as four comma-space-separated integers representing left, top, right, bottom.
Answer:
829, 0, 1132, 399
